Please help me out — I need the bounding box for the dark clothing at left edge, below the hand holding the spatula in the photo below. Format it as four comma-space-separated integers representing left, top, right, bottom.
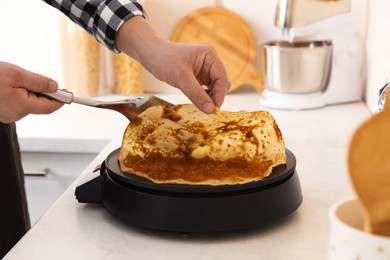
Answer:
0, 123, 30, 259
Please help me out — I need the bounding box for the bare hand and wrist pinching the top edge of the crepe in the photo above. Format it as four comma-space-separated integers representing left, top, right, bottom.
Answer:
116, 17, 230, 113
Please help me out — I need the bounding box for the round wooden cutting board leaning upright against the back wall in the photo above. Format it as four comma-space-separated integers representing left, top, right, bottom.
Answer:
171, 7, 263, 92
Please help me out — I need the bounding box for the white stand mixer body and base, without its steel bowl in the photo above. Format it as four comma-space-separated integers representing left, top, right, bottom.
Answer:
260, 0, 363, 110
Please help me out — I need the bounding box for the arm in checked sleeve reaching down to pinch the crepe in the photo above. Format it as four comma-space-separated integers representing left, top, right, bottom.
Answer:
44, 0, 230, 113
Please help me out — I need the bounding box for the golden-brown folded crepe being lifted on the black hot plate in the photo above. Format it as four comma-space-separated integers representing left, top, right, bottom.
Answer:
118, 104, 286, 185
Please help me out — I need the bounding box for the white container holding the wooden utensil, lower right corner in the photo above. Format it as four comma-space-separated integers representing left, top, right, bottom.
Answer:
328, 197, 390, 260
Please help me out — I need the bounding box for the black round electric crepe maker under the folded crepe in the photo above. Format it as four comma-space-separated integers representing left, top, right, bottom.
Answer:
75, 149, 303, 233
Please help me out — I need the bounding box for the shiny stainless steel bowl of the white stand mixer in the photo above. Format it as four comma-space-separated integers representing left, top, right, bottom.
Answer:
260, 41, 332, 94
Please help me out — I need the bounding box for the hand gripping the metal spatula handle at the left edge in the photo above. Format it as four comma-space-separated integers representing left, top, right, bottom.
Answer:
0, 62, 63, 123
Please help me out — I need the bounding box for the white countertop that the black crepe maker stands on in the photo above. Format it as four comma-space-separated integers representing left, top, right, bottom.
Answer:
5, 93, 370, 260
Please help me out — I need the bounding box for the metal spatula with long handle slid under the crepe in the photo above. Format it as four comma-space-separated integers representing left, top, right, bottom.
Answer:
39, 89, 173, 121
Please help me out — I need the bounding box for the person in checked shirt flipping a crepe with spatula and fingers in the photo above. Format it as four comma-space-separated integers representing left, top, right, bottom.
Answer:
0, 0, 230, 258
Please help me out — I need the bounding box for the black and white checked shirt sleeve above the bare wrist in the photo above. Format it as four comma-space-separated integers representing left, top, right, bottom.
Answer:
43, 0, 146, 53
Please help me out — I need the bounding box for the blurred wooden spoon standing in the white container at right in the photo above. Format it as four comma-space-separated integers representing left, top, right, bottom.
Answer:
348, 102, 390, 236
